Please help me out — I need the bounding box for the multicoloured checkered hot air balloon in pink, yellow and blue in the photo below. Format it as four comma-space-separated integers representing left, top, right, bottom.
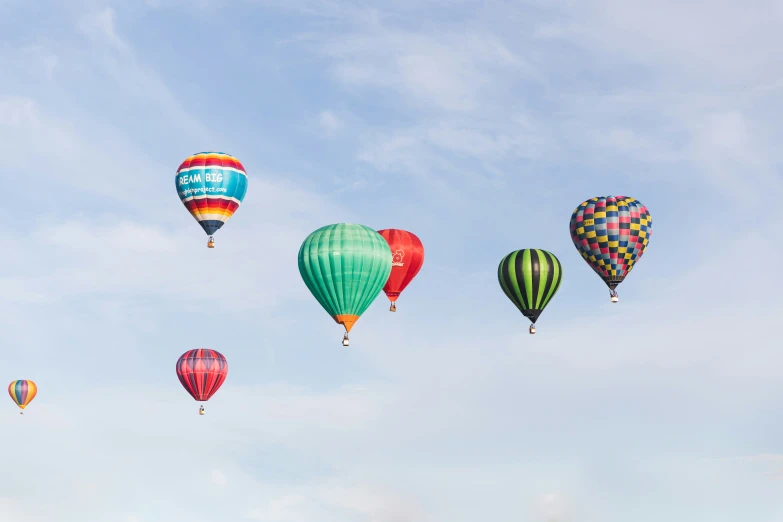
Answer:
570, 196, 652, 303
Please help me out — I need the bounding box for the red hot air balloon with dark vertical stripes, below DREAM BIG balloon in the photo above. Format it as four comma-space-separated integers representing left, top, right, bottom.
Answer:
177, 348, 228, 415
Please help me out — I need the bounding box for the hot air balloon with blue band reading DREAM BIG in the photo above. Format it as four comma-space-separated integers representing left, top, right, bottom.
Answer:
174, 152, 247, 248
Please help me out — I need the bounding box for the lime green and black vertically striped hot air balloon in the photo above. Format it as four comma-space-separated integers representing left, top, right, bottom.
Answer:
498, 248, 563, 334
